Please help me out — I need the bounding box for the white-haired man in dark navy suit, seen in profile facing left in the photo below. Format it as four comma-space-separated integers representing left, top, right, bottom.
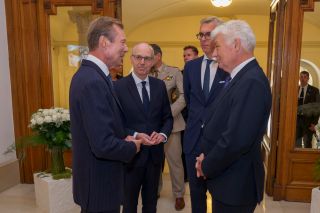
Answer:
196, 20, 271, 213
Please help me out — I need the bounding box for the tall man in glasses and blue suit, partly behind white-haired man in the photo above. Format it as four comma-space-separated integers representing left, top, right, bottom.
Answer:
183, 17, 228, 213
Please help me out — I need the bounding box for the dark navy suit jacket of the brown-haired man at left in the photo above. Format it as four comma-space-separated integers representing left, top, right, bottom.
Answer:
70, 60, 136, 212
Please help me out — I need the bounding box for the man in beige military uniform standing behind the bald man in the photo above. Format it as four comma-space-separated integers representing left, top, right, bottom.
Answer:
151, 44, 186, 210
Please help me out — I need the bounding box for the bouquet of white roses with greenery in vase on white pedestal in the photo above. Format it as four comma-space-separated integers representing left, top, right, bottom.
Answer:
8, 108, 71, 179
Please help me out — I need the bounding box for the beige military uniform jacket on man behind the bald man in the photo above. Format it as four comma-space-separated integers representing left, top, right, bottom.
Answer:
154, 64, 186, 132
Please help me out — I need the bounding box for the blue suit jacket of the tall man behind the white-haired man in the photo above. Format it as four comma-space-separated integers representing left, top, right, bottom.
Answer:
183, 56, 229, 153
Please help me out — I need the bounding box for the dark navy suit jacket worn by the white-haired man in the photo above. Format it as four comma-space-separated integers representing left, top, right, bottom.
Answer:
201, 60, 271, 205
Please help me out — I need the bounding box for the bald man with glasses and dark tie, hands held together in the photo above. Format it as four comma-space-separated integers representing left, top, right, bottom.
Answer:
114, 43, 173, 213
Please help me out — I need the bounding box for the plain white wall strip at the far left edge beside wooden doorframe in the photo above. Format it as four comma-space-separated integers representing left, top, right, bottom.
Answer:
0, 0, 16, 165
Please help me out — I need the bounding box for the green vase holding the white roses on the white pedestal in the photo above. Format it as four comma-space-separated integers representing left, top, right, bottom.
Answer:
51, 146, 65, 175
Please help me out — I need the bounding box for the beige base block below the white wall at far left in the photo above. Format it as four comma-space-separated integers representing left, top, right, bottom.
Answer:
0, 160, 20, 192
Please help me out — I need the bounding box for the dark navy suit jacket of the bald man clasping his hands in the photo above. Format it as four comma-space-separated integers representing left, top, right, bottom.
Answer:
114, 74, 173, 167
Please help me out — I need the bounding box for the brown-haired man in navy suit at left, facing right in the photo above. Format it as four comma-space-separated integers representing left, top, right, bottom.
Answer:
70, 17, 141, 213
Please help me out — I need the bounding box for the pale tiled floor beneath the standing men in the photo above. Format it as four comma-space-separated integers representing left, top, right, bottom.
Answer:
0, 174, 310, 213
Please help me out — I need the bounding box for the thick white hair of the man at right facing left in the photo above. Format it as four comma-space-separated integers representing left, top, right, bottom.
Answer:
211, 20, 256, 52
